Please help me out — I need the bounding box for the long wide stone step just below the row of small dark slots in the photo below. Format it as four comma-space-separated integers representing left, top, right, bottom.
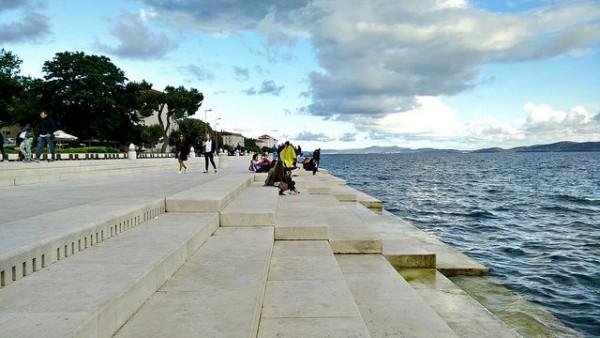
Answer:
0, 213, 219, 337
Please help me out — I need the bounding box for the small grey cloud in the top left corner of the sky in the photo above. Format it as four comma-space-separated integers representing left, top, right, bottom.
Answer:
0, 0, 50, 43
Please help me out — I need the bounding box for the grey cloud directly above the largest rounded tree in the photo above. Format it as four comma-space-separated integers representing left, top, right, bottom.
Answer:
98, 12, 177, 60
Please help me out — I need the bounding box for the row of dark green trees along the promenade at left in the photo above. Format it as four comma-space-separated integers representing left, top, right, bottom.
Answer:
0, 49, 204, 151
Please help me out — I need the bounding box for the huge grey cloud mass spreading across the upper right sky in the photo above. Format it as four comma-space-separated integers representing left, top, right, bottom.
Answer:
138, 0, 600, 137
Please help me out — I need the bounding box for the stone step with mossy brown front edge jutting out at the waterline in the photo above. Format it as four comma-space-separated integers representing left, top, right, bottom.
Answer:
347, 204, 488, 276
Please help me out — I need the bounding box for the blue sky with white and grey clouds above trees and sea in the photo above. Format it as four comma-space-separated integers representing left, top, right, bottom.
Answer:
0, 0, 600, 150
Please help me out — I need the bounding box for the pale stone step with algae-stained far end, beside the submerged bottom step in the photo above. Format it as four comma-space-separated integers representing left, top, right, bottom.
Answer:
399, 269, 520, 338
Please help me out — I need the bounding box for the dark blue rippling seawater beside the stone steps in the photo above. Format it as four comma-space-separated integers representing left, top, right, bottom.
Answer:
321, 153, 600, 337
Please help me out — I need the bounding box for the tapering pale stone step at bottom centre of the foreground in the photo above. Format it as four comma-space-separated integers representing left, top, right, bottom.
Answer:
258, 241, 369, 337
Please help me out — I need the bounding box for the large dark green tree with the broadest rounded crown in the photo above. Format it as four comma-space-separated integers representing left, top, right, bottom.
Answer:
43, 52, 149, 143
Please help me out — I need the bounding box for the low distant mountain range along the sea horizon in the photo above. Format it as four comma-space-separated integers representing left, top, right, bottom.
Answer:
321, 142, 600, 154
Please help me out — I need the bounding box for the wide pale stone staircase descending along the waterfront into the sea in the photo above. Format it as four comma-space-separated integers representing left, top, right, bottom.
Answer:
0, 159, 518, 337
